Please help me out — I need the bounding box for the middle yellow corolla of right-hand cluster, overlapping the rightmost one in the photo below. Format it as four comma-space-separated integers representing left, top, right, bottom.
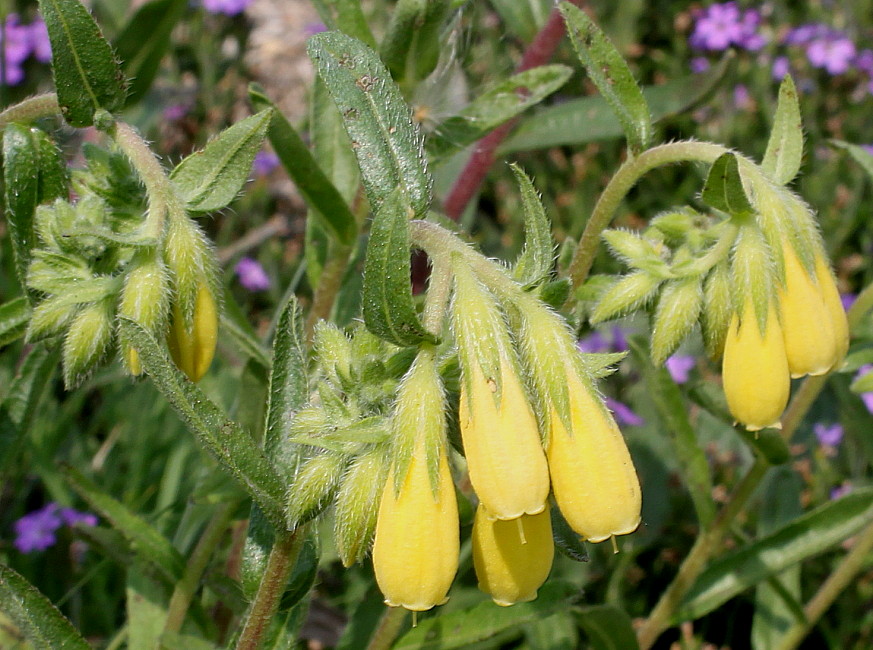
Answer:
779, 242, 836, 377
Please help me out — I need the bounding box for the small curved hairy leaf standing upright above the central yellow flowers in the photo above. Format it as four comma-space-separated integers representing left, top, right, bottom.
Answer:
510, 164, 555, 284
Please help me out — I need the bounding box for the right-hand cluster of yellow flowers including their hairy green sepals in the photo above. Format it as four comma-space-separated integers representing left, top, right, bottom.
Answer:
722, 183, 849, 430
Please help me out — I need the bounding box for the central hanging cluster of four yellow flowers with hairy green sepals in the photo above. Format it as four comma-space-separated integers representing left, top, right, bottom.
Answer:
373, 259, 641, 611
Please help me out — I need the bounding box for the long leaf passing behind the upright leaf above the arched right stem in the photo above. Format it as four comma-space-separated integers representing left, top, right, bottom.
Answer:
499, 52, 732, 155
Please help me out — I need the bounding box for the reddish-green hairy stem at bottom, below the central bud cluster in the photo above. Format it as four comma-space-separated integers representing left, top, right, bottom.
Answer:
236, 528, 305, 650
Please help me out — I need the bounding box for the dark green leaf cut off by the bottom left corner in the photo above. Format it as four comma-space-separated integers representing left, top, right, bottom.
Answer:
0, 564, 91, 650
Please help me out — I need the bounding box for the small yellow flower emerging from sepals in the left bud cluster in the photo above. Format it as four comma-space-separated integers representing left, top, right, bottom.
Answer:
167, 284, 218, 381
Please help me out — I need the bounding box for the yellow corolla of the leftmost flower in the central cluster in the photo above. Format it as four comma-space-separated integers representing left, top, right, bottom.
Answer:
373, 440, 460, 612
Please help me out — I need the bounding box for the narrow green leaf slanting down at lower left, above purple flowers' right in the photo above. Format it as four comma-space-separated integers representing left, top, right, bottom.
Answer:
61, 465, 185, 583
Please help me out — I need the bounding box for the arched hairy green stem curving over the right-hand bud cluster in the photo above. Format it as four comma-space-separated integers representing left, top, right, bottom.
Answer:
569, 142, 729, 289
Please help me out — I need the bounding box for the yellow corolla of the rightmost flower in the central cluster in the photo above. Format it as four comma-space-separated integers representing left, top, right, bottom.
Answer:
548, 364, 642, 542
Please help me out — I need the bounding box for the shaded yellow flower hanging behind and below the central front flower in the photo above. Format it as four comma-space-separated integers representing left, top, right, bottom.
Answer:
473, 504, 555, 607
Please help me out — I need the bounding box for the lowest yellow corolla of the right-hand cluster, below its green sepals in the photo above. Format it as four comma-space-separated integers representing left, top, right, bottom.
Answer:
722, 300, 790, 431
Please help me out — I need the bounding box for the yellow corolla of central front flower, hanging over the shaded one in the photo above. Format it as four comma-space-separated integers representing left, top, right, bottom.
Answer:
460, 359, 549, 519
